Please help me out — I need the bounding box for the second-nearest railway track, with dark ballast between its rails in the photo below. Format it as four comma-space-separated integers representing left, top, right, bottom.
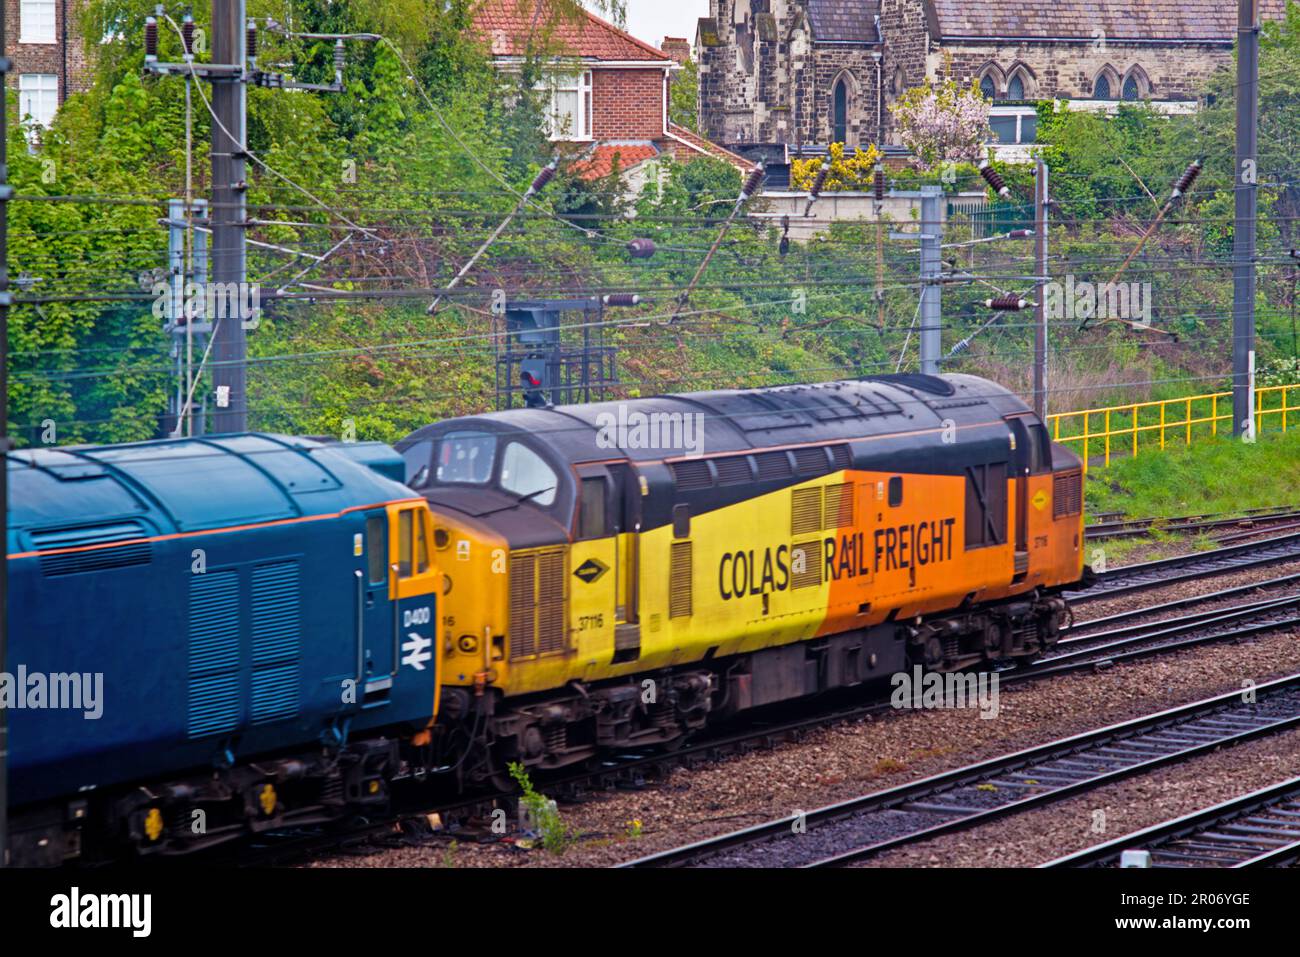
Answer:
624, 675, 1300, 867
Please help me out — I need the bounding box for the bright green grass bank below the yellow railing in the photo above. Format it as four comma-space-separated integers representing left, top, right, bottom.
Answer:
1084, 432, 1300, 564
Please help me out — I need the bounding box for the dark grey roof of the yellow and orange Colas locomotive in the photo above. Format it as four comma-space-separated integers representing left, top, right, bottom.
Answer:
399, 374, 1030, 463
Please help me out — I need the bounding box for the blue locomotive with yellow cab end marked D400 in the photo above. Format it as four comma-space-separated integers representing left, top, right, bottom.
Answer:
0, 434, 442, 863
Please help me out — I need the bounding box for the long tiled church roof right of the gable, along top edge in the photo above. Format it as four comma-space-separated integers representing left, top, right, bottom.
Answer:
930, 0, 1286, 43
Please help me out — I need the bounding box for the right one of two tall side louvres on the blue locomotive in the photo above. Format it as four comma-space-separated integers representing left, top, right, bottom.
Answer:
251, 562, 302, 724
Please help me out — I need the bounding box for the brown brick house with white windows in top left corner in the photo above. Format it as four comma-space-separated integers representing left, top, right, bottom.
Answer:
4, 0, 90, 126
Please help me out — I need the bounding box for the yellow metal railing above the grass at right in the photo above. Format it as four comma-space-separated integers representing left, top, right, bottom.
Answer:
1048, 385, 1300, 475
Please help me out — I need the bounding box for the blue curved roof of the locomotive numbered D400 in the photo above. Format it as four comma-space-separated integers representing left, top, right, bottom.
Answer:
8, 433, 411, 540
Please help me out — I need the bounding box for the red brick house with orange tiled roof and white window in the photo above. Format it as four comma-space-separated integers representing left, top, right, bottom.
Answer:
473, 0, 753, 192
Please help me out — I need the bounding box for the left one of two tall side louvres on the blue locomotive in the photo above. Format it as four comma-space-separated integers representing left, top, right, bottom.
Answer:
187, 570, 239, 737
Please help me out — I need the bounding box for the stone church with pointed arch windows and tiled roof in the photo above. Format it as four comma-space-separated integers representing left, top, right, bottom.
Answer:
696, 0, 1286, 146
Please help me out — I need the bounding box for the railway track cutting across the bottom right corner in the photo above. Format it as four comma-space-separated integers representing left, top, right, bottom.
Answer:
1041, 778, 1300, 867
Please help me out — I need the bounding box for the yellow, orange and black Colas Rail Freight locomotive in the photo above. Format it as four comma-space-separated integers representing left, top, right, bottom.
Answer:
397, 374, 1084, 779
